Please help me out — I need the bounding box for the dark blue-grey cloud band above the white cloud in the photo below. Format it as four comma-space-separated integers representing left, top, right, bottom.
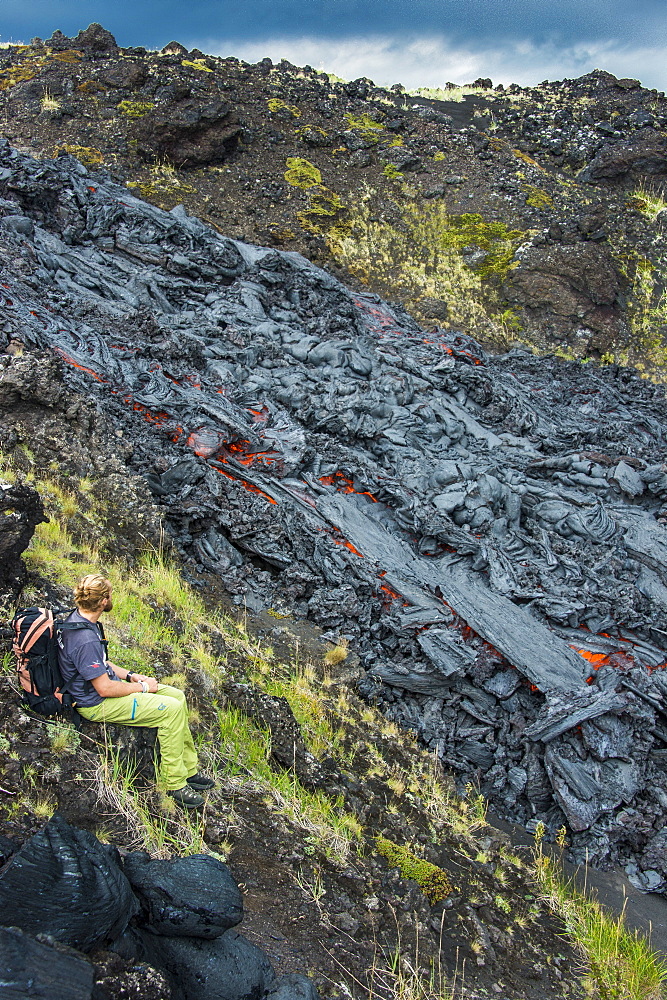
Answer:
5, 0, 667, 47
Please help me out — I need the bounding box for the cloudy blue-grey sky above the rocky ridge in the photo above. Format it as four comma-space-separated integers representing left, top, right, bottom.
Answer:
0, 0, 667, 90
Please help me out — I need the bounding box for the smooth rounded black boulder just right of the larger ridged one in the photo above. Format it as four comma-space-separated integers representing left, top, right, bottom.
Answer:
124, 852, 243, 940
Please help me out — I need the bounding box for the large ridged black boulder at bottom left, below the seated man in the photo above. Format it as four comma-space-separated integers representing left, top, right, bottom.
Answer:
0, 813, 139, 951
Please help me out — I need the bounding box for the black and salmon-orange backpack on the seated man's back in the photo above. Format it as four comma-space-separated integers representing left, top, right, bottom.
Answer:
11, 608, 104, 721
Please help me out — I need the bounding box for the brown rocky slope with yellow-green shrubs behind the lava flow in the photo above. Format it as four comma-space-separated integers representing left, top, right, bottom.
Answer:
0, 26, 667, 372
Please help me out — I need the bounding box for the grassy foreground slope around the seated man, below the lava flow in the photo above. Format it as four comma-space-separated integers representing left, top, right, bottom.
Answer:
0, 452, 667, 1000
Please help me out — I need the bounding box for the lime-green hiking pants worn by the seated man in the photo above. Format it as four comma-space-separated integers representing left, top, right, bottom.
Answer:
77, 684, 197, 791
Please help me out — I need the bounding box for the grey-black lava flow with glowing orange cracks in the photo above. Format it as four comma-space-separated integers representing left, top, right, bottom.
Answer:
0, 145, 667, 884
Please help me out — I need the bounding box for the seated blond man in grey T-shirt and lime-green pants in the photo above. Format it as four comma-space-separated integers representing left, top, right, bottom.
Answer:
58, 573, 215, 809
